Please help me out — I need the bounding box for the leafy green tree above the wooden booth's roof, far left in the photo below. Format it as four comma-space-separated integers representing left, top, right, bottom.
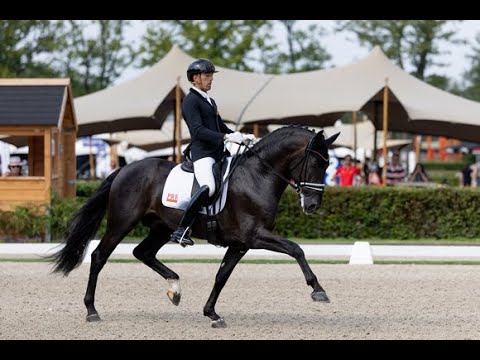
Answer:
0, 20, 63, 77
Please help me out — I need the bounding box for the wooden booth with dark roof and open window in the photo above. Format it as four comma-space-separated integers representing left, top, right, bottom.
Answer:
0, 79, 77, 211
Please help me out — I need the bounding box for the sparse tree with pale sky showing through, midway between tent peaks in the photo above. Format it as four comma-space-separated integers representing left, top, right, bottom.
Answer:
260, 20, 331, 74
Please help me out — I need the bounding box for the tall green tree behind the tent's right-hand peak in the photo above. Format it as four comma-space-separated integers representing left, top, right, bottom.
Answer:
337, 20, 464, 89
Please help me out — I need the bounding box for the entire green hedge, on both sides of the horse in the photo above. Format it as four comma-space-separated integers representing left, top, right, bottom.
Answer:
0, 182, 480, 241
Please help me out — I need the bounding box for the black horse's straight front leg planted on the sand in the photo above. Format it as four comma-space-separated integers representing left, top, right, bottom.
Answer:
203, 247, 247, 328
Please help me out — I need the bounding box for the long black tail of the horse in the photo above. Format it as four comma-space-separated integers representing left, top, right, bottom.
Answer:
48, 169, 121, 276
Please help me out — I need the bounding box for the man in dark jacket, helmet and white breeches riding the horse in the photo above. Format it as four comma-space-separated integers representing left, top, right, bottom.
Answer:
170, 59, 251, 246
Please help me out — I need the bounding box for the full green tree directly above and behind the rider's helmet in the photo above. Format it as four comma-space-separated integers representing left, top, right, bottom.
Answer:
140, 20, 271, 71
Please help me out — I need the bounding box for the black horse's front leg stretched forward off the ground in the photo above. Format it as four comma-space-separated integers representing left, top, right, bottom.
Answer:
251, 229, 330, 302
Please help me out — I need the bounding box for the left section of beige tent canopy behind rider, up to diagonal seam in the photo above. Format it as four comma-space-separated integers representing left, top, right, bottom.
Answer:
75, 46, 270, 137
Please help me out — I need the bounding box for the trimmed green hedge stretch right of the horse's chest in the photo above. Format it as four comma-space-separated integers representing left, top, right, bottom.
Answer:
277, 187, 480, 239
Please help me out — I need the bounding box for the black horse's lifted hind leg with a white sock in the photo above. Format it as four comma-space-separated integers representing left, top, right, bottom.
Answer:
133, 225, 182, 305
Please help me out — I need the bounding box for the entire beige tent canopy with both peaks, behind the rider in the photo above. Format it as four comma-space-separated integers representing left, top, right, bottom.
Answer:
75, 46, 480, 142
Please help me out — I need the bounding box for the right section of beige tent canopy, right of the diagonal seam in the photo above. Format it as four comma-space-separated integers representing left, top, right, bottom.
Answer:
241, 47, 480, 141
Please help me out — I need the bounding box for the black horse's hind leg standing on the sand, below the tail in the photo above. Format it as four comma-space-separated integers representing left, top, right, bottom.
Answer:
83, 217, 137, 322
